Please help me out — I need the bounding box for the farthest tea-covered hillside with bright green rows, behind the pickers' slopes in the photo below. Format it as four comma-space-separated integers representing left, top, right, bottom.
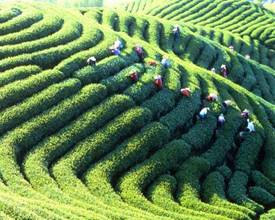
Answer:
126, 0, 275, 50
